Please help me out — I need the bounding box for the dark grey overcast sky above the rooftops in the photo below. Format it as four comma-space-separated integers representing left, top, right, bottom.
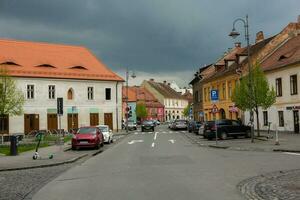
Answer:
0, 0, 300, 86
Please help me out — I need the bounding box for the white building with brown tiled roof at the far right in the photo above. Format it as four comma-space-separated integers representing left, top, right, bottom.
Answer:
246, 32, 300, 133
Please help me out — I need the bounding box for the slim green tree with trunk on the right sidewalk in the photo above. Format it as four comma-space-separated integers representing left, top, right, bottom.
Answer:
232, 63, 276, 136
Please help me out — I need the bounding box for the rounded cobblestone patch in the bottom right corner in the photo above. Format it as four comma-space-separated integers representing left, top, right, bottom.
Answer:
237, 169, 300, 200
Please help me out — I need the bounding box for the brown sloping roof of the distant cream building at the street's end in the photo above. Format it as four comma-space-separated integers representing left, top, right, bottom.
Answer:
147, 81, 183, 99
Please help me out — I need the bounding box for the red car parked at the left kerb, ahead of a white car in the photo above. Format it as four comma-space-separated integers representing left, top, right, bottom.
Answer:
72, 126, 104, 150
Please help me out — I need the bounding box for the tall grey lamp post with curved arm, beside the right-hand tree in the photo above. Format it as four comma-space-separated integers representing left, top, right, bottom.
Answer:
229, 15, 254, 142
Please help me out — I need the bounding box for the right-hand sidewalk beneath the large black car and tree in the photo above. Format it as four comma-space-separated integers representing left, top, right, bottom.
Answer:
184, 130, 300, 152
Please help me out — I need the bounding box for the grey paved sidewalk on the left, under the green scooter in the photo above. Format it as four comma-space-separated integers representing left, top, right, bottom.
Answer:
0, 144, 87, 171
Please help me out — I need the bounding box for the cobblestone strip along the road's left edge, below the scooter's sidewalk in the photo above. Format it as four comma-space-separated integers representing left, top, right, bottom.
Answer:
0, 135, 124, 200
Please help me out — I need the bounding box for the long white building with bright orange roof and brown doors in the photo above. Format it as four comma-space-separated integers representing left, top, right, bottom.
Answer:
0, 40, 123, 134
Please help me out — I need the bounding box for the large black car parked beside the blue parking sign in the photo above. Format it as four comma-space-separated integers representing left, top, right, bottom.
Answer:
203, 119, 251, 140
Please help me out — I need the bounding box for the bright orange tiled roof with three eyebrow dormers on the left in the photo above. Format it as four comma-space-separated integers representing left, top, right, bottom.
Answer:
0, 39, 123, 81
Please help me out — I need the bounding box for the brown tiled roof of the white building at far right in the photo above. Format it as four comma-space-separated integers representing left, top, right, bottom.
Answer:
261, 35, 300, 71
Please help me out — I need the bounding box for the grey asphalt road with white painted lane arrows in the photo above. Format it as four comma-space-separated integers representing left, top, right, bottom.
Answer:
33, 126, 300, 200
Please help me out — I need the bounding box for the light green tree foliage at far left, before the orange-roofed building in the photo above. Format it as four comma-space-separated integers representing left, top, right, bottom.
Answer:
0, 68, 25, 122
